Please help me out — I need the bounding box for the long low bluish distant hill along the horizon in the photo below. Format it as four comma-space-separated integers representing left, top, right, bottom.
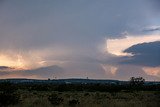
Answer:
0, 78, 160, 85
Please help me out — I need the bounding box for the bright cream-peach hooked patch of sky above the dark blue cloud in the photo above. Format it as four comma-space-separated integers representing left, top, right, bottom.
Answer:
105, 35, 160, 56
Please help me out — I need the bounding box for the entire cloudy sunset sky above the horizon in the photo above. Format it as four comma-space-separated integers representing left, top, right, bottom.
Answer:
0, 0, 160, 81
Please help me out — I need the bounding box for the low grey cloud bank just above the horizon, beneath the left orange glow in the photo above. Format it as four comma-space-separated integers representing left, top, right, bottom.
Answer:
0, 65, 64, 79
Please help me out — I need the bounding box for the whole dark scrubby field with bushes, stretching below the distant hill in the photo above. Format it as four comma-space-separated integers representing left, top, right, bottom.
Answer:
0, 80, 160, 107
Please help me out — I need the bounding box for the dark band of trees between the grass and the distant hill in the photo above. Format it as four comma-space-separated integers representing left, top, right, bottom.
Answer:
0, 80, 160, 93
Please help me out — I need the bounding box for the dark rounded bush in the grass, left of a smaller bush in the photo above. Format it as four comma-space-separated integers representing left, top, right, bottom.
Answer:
48, 94, 63, 105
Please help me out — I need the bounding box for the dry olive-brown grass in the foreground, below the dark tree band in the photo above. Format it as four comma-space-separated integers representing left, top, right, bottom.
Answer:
5, 90, 160, 107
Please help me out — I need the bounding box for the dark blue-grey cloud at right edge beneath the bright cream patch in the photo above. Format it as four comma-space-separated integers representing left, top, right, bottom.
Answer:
123, 41, 160, 67
